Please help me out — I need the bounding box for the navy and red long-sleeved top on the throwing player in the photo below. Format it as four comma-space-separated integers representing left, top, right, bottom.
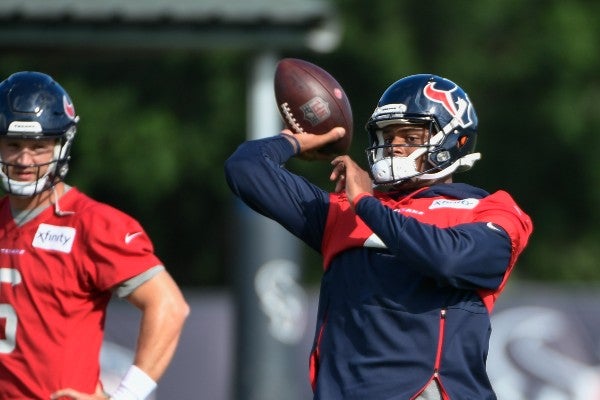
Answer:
225, 136, 532, 400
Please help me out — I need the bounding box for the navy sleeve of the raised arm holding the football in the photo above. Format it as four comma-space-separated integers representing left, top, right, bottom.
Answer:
225, 135, 329, 251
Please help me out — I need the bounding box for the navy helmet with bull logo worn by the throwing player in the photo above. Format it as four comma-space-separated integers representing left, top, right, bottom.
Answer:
366, 74, 481, 185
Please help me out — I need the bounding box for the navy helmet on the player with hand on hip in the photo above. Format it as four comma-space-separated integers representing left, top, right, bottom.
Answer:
0, 71, 79, 196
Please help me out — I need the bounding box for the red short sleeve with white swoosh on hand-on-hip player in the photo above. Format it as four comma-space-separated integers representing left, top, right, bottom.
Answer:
76, 204, 162, 290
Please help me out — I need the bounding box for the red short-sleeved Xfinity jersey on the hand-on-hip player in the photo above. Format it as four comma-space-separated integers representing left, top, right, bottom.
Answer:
0, 188, 162, 400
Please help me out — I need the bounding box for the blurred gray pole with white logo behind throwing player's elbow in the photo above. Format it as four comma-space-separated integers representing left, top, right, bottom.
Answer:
233, 53, 308, 400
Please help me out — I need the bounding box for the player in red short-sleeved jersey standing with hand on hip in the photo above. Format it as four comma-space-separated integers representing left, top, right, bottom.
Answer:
0, 71, 189, 400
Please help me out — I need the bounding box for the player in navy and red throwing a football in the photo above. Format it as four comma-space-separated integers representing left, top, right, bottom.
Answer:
225, 74, 532, 400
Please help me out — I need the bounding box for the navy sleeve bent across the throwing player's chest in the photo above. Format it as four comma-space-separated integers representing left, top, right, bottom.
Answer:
356, 196, 511, 289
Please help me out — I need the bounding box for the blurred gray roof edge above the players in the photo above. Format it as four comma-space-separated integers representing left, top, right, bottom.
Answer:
0, 0, 340, 52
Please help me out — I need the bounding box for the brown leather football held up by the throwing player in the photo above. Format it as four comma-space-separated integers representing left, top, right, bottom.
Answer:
275, 58, 353, 156
